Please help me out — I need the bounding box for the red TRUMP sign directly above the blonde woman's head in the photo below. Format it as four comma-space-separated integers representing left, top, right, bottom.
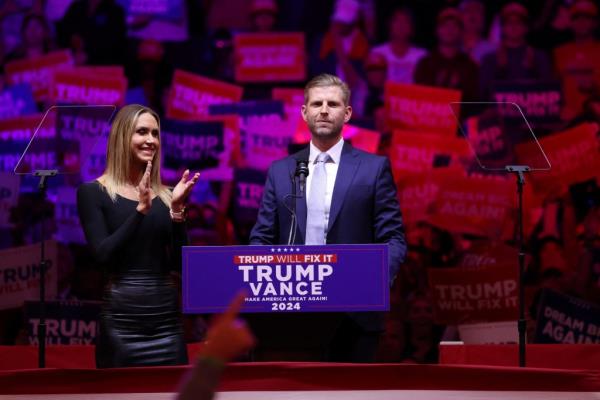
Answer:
50, 67, 127, 106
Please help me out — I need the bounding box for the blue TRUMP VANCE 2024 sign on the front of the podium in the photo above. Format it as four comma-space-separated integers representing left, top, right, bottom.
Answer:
183, 244, 390, 313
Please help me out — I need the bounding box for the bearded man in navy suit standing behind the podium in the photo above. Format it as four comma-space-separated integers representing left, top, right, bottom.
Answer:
250, 74, 406, 362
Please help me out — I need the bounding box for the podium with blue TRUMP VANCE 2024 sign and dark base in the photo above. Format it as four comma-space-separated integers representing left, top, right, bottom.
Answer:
182, 244, 390, 361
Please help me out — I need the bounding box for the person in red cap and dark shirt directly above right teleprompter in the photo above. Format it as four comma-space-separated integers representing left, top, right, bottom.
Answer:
479, 2, 552, 99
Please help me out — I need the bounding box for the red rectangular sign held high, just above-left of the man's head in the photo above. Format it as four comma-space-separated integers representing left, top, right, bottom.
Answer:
233, 32, 306, 82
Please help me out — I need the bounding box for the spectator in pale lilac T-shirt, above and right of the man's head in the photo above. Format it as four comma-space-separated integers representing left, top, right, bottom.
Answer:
371, 8, 427, 83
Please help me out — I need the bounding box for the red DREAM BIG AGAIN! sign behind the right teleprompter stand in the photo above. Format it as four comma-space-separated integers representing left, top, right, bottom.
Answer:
430, 177, 516, 238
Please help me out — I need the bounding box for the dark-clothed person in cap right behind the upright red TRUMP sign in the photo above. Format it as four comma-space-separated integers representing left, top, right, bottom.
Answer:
414, 8, 479, 101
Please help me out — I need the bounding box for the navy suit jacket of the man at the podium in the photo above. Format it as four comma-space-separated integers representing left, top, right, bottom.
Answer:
250, 142, 406, 331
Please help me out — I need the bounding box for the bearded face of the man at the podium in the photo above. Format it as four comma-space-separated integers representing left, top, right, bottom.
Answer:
302, 86, 352, 139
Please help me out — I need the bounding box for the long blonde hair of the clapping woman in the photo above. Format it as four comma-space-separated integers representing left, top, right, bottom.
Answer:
99, 104, 172, 207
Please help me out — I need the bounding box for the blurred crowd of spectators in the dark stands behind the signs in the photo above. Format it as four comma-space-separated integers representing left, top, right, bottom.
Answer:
0, 0, 600, 363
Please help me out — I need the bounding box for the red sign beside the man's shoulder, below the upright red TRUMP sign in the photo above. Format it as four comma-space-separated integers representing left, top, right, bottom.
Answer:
390, 130, 471, 179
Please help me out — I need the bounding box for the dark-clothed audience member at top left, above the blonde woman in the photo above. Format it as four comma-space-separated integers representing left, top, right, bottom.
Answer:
57, 0, 127, 65
